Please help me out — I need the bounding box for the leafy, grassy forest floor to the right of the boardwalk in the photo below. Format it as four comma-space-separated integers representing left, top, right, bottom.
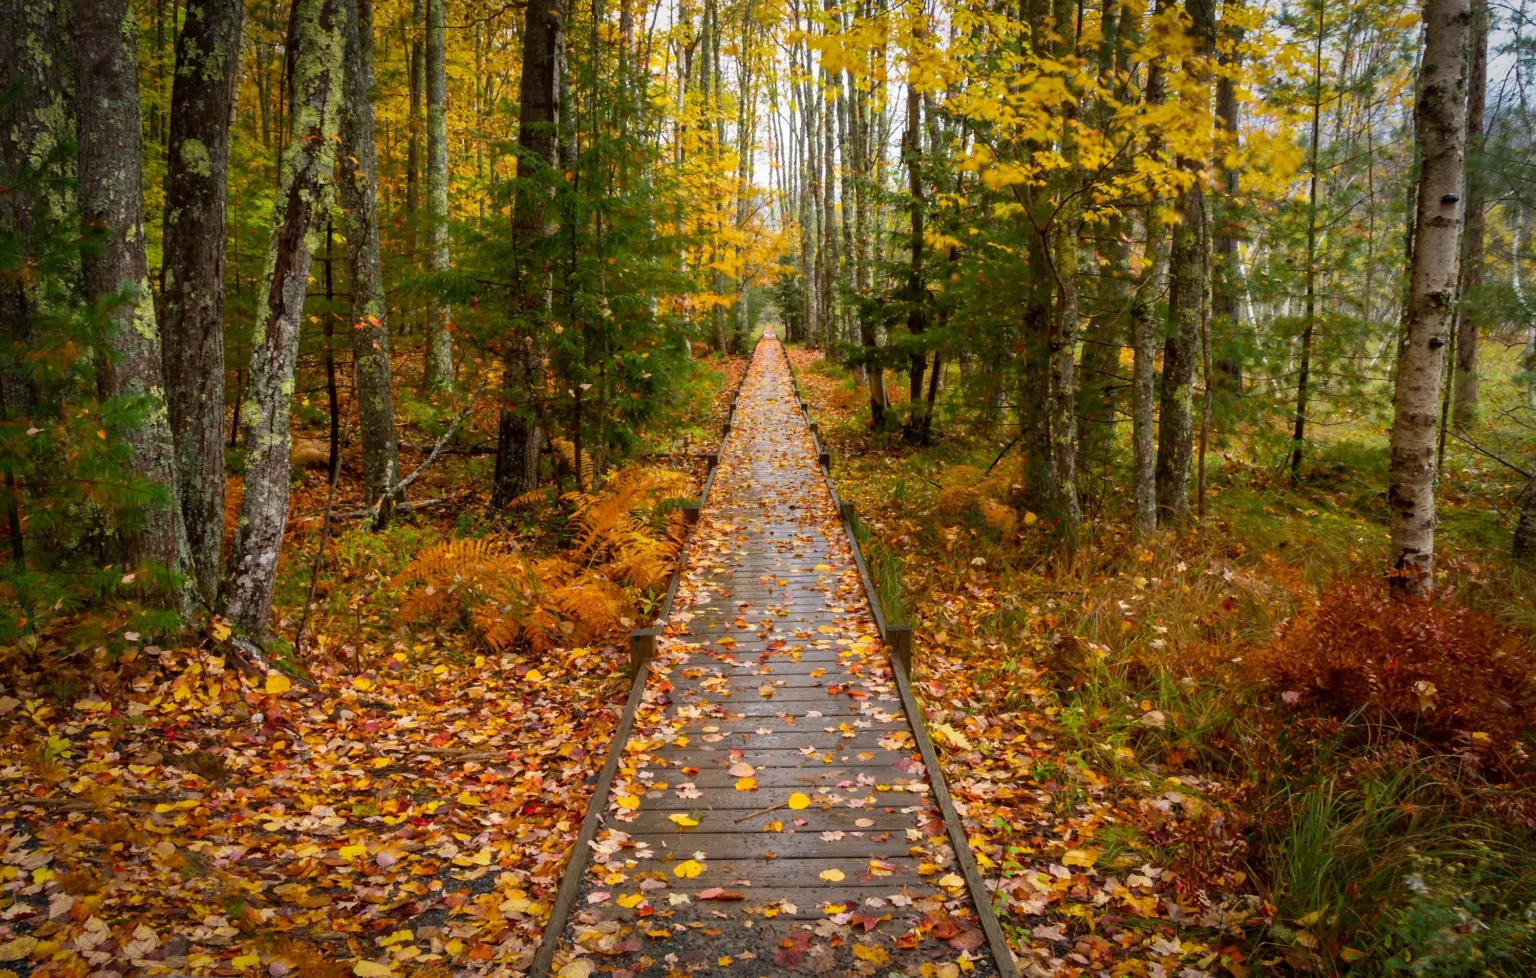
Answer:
791, 349, 1536, 978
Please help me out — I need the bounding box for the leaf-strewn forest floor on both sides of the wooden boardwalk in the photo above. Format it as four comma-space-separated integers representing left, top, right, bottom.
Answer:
0, 339, 1536, 978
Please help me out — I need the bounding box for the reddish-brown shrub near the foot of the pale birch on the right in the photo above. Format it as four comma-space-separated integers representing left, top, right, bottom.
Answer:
1256, 580, 1536, 780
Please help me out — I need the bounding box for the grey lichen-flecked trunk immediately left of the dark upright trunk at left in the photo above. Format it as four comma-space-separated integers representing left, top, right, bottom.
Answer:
69, 0, 186, 580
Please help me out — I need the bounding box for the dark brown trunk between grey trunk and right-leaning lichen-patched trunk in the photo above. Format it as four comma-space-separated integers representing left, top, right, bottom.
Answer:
160, 0, 244, 605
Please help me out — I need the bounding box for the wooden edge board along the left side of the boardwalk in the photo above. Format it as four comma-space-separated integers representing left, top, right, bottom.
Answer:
528, 338, 762, 978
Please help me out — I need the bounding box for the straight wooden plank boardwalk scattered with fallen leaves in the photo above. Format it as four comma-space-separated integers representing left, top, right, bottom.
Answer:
554, 335, 994, 978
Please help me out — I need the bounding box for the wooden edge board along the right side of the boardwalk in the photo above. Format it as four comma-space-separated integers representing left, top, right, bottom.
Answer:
779, 342, 1018, 978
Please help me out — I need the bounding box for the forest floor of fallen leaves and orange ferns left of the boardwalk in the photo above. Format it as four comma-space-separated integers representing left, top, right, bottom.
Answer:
0, 361, 745, 978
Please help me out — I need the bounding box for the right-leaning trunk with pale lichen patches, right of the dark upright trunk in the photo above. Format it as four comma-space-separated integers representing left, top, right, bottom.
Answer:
224, 0, 349, 637
